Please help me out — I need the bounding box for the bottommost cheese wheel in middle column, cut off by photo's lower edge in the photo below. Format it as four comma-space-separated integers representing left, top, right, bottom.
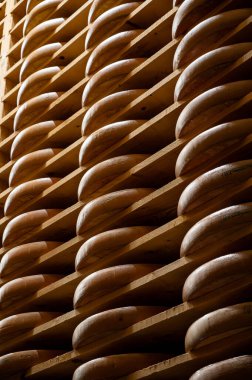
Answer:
73, 353, 167, 380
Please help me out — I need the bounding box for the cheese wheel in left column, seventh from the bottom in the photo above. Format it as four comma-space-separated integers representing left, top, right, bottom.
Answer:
9, 148, 61, 186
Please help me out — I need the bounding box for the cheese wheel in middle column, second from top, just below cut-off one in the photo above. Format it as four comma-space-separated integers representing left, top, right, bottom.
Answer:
85, 2, 141, 50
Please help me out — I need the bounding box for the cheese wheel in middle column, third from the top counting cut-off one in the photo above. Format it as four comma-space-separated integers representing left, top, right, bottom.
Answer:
86, 29, 143, 75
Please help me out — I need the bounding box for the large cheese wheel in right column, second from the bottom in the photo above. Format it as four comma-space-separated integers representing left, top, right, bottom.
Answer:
185, 302, 252, 354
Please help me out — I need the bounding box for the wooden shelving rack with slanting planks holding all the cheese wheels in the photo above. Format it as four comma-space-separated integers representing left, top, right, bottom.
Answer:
0, 0, 252, 380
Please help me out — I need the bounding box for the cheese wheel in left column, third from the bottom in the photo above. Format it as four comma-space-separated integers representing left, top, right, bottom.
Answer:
0, 274, 61, 308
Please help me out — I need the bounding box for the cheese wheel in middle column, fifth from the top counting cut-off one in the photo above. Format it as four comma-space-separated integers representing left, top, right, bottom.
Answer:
81, 89, 145, 136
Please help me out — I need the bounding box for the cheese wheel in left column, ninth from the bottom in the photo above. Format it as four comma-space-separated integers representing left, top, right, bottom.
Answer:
13, 92, 59, 131
